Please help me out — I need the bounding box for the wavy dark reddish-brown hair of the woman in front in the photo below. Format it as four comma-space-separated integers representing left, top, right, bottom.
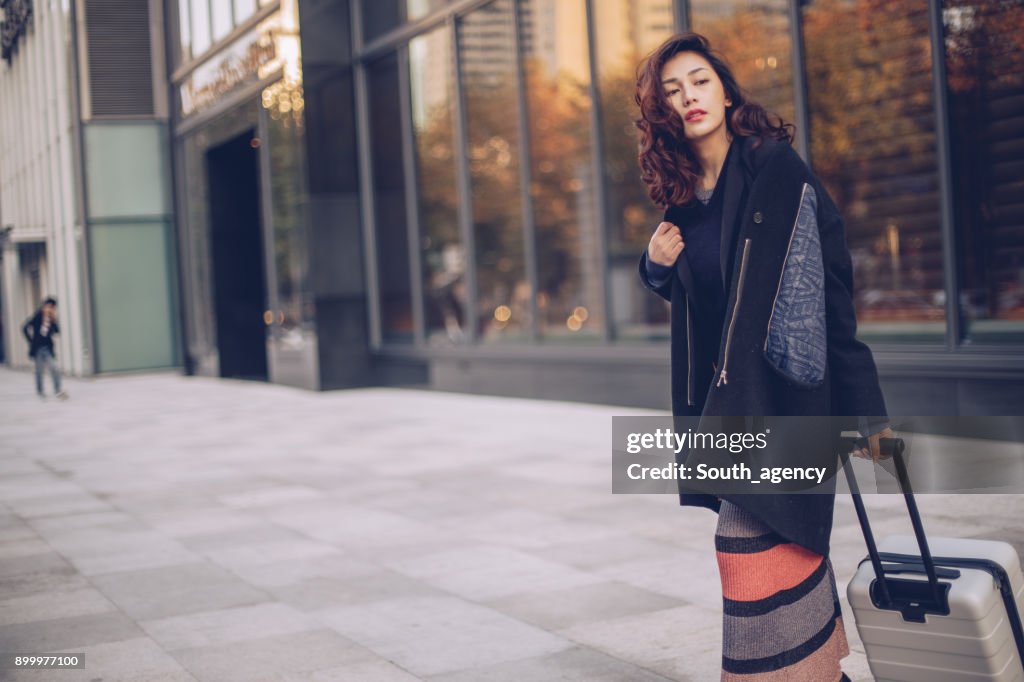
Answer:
634, 32, 796, 208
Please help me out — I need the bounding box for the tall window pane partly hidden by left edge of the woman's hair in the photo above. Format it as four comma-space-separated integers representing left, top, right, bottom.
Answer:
593, 0, 674, 341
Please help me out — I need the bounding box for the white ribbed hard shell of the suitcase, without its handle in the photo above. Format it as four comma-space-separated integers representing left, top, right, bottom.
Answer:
847, 536, 1024, 682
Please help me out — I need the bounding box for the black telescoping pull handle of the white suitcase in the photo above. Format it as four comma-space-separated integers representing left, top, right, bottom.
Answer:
842, 435, 945, 608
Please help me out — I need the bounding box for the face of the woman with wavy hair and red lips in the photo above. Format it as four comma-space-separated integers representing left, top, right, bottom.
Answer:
662, 52, 732, 141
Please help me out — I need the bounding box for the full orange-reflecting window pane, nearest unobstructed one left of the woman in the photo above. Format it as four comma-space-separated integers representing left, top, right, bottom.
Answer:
519, 0, 604, 340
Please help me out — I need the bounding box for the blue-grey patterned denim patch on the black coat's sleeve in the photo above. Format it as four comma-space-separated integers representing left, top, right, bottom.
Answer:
765, 183, 827, 386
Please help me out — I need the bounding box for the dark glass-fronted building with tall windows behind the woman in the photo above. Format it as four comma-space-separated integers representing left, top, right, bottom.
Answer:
168, 0, 1024, 415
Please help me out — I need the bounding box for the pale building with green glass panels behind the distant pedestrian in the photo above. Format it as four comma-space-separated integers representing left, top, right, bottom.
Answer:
0, 0, 180, 375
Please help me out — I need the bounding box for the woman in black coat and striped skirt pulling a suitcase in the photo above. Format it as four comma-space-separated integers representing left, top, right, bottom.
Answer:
636, 33, 893, 682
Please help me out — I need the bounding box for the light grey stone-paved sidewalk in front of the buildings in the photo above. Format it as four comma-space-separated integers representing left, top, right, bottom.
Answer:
0, 369, 1024, 682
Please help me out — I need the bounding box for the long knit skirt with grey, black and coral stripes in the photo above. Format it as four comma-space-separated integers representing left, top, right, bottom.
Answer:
715, 500, 850, 682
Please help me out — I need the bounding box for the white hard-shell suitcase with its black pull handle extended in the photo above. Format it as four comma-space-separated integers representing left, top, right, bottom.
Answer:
844, 441, 1024, 682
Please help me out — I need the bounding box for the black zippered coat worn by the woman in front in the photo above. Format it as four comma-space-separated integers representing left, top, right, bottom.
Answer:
640, 136, 887, 554
